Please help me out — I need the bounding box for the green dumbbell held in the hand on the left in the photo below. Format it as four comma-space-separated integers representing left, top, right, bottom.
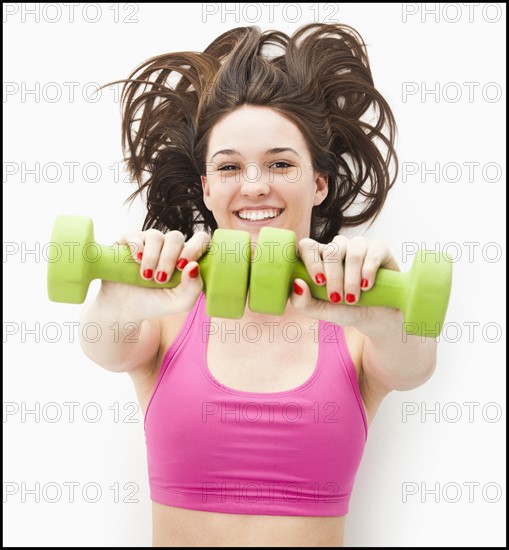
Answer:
47, 215, 251, 319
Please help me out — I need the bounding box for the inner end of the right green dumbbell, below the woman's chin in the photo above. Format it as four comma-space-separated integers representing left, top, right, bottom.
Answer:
249, 227, 297, 315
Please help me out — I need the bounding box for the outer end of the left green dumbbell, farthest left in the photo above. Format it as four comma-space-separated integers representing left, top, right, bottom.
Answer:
47, 215, 94, 304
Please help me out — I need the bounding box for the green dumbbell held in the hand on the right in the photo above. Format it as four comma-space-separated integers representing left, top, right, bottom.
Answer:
249, 227, 452, 337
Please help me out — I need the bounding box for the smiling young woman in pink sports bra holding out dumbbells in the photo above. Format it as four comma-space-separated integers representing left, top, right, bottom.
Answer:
81, 24, 436, 546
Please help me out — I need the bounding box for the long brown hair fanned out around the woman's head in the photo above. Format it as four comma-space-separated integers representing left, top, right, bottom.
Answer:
109, 23, 398, 243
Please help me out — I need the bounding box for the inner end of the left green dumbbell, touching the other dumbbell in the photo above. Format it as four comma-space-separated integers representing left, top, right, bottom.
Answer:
200, 229, 251, 319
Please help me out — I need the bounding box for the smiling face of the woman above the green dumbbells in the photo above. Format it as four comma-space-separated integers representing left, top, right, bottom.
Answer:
201, 105, 328, 242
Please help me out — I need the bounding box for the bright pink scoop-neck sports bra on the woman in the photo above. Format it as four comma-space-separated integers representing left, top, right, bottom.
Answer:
145, 292, 368, 516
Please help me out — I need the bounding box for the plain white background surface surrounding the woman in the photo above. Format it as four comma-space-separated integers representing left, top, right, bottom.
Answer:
3, 4, 506, 546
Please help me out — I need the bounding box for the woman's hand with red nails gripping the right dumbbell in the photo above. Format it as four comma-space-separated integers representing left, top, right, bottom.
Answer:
290, 235, 402, 333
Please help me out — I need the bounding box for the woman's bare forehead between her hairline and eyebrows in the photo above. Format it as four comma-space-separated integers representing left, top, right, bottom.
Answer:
205, 105, 306, 152
